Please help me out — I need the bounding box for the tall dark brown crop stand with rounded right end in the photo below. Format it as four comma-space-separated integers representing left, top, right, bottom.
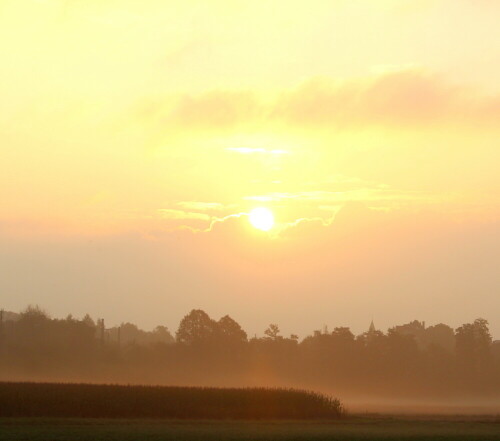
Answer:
0, 382, 343, 420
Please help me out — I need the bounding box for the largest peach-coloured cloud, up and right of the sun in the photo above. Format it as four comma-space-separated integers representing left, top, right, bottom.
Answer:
274, 68, 499, 127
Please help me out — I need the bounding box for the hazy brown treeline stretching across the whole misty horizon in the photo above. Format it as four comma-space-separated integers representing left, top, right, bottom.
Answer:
0, 307, 500, 398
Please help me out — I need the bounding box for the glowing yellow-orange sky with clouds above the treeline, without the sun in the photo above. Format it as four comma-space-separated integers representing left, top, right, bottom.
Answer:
0, 0, 500, 338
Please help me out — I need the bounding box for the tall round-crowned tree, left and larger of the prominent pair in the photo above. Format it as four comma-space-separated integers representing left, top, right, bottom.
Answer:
175, 309, 218, 345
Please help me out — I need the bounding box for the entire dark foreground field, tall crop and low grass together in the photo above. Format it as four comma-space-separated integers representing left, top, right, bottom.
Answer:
0, 383, 500, 441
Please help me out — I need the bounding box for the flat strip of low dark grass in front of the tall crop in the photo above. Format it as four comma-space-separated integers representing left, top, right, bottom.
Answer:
0, 417, 500, 441
